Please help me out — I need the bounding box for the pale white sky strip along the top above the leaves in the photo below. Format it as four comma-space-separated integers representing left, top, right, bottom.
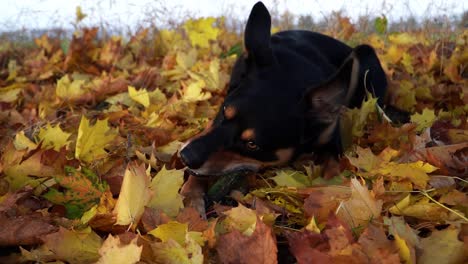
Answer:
0, 0, 468, 31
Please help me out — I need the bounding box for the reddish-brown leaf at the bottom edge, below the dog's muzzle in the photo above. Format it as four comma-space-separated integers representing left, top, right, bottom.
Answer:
216, 219, 278, 264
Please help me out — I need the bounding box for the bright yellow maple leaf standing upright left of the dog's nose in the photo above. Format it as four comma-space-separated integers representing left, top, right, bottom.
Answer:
75, 116, 118, 162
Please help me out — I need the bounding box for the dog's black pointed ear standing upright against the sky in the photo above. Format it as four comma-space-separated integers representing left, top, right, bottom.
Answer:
244, 2, 274, 66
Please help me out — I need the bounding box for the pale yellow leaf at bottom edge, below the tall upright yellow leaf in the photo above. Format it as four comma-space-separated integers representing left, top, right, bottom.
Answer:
96, 235, 143, 264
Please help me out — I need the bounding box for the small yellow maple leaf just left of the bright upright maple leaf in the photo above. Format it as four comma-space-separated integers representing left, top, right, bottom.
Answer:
37, 123, 71, 151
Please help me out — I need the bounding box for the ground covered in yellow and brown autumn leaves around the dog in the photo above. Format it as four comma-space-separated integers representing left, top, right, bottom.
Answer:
0, 11, 468, 263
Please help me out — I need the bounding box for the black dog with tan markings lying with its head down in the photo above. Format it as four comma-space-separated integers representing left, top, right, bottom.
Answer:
180, 2, 387, 175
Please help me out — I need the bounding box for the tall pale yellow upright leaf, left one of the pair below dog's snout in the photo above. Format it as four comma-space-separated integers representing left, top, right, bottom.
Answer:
114, 163, 152, 227
